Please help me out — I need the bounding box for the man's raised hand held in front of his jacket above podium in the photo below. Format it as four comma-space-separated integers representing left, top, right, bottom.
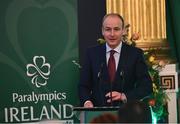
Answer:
105, 91, 123, 103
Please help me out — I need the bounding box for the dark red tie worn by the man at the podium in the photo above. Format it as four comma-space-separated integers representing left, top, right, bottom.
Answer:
108, 50, 116, 82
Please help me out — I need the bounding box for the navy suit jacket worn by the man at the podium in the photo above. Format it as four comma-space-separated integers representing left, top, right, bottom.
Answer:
78, 43, 152, 106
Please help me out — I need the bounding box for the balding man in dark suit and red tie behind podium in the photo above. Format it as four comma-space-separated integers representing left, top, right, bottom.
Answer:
78, 13, 152, 107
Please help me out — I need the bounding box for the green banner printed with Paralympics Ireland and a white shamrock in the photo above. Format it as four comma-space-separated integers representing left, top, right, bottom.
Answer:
0, 0, 79, 123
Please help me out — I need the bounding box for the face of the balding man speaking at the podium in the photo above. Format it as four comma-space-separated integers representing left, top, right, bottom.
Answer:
102, 16, 124, 49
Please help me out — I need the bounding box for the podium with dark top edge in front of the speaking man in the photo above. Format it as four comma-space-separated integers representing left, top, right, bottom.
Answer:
73, 107, 119, 123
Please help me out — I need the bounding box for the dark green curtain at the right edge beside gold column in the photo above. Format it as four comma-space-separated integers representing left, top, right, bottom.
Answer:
166, 0, 180, 68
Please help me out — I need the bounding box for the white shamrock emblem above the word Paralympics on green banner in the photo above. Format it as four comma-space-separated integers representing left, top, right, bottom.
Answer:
26, 56, 50, 88
